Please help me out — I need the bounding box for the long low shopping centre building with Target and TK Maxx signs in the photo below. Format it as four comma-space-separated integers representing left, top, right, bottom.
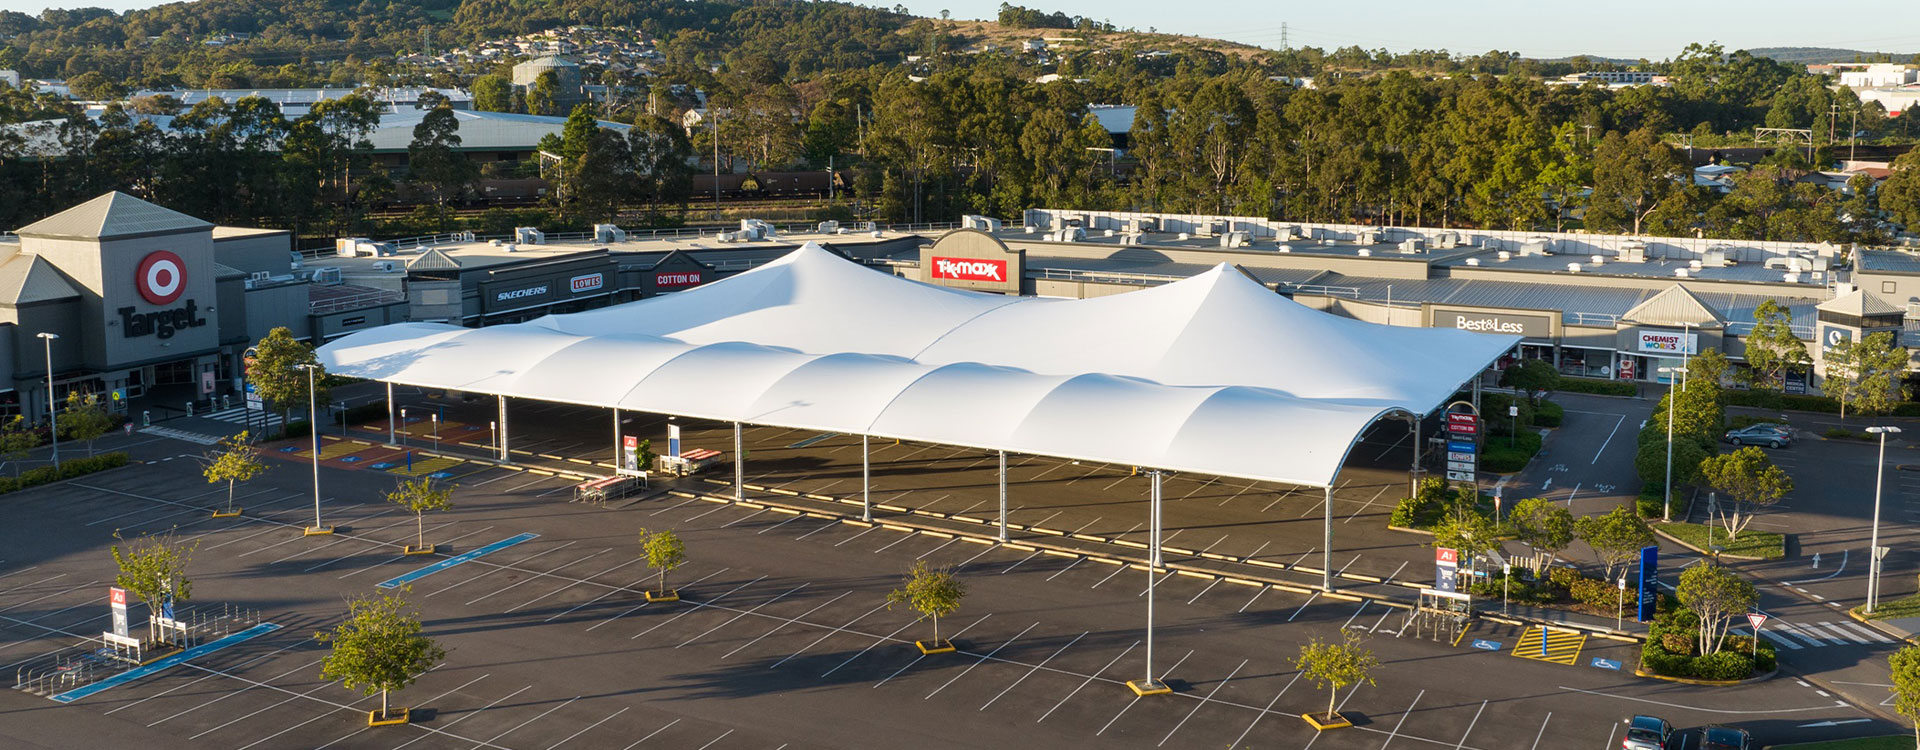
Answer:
0, 194, 1920, 421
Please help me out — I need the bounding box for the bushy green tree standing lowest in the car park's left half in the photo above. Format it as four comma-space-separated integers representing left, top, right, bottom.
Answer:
313, 595, 447, 719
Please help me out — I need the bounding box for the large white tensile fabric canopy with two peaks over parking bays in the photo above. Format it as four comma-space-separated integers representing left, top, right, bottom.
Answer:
319, 244, 1519, 487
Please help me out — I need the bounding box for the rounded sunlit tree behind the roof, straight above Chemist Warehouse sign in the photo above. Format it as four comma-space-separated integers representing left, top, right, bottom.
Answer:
1586, 129, 1684, 234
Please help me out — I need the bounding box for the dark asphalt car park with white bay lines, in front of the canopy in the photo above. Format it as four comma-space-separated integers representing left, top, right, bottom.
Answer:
0, 439, 1887, 750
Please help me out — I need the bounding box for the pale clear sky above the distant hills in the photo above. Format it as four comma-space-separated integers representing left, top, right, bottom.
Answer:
11, 0, 1920, 59
